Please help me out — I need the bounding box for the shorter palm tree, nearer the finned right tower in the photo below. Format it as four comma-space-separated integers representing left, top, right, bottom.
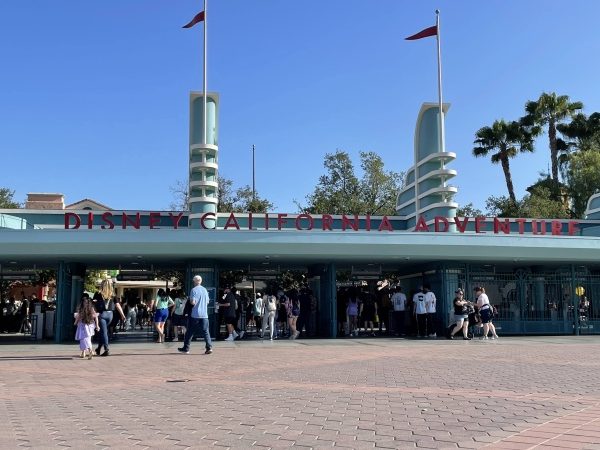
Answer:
473, 120, 533, 204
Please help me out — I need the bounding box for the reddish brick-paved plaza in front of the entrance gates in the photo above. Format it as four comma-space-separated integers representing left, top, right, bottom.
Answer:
0, 336, 600, 449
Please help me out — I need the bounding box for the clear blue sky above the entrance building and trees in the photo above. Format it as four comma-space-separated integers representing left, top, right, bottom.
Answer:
0, 0, 600, 212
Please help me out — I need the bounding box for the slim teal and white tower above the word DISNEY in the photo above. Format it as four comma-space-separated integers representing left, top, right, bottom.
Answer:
189, 92, 219, 228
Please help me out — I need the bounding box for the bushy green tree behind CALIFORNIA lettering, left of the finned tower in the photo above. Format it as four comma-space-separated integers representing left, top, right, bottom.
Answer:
296, 150, 404, 215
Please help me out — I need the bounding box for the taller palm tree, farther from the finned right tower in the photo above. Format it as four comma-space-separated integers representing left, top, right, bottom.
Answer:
521, 92, 583, 183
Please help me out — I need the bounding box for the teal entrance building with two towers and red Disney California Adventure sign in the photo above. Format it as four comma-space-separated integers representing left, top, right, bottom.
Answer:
0, 93, 600, 342
